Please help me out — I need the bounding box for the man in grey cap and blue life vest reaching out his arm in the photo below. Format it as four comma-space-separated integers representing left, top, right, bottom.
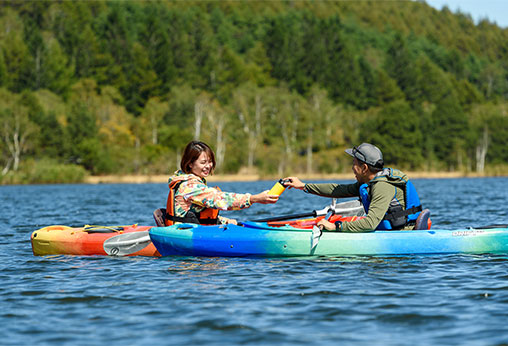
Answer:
285, 143, 422, 232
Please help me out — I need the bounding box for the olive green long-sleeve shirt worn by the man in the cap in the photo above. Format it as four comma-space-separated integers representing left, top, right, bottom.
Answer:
304, 181, 411, 232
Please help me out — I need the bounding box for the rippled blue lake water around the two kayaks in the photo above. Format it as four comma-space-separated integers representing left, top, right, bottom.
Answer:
0, 178, 508, 345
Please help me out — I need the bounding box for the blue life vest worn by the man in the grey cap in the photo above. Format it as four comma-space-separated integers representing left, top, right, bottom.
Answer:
359, 168, 422, 230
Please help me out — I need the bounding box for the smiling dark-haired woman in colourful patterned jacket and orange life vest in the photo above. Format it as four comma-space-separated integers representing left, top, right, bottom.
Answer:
165, 141, 279, 226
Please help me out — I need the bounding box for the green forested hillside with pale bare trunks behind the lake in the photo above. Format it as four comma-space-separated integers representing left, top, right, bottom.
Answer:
0, 0, 508, 184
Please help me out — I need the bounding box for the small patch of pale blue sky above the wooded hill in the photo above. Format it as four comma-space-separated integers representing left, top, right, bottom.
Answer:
425, 0, 508, 28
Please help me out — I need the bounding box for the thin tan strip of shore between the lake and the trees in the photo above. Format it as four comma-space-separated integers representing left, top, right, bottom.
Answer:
83, 171, 500, 184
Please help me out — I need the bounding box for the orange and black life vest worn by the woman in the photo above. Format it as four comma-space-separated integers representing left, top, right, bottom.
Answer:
164, 181, 220, 226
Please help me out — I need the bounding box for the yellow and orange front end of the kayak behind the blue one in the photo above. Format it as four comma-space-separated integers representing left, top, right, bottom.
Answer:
30, 225, 160, 256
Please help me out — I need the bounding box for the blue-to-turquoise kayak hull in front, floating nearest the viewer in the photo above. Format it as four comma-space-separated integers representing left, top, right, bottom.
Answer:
149, 222, 508, 257
